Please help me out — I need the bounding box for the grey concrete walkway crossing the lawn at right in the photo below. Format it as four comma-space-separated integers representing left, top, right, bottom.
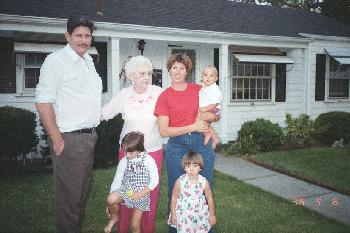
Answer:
215, 154, 350, 225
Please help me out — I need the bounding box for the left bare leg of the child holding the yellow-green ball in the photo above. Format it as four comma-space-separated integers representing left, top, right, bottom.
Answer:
104, 192, 122, 233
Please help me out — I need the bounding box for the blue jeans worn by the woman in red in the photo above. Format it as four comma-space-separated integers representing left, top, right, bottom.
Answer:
166, 132, 215, 233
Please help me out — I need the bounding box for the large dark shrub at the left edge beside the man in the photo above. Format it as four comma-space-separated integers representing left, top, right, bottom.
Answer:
0, 106, 38, 160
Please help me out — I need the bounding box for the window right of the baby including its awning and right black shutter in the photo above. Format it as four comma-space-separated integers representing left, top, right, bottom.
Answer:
231, 51, 294, 102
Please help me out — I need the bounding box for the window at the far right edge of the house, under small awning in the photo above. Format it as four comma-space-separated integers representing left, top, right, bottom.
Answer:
328, 58, 350, 98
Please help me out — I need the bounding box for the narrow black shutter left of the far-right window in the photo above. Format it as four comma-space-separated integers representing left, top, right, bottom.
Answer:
315, 54, 326, 101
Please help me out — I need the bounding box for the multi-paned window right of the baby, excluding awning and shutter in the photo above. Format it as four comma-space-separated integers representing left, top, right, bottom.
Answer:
231, 61, 273, 101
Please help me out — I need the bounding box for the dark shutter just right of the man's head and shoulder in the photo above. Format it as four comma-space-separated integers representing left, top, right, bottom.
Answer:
94, 42, 107, 92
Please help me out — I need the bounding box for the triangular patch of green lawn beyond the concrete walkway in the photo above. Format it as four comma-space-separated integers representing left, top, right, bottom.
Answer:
249, 146, 350, 195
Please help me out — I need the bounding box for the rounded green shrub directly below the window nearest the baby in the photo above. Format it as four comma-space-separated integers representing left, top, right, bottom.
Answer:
237, 118, 283, 153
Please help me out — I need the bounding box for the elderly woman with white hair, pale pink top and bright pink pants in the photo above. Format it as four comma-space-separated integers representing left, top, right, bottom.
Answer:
102, 56, 163, 233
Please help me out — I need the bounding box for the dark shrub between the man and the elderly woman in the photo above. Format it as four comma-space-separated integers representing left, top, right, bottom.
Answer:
94, 115, 123, 167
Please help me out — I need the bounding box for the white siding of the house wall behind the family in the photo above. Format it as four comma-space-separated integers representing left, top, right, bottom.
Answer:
0, 38, 350, 145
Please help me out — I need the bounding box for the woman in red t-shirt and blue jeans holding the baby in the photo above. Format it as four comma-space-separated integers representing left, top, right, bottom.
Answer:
154, 54, 218, 232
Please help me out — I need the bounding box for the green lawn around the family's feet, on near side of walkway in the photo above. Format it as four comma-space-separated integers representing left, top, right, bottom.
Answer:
0, 165, 350, 233
